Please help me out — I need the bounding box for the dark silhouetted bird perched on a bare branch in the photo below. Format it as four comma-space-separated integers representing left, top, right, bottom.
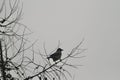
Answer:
47, 48, 63, 62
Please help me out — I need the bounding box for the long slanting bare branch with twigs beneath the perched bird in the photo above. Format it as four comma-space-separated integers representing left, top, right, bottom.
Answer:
24, 41, 83, 80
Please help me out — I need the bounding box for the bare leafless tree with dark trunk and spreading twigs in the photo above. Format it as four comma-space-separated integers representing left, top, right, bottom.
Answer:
0, 0, 85, 80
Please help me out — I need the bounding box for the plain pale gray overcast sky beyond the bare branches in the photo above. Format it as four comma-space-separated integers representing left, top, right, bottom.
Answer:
22, 0, 120, 80
